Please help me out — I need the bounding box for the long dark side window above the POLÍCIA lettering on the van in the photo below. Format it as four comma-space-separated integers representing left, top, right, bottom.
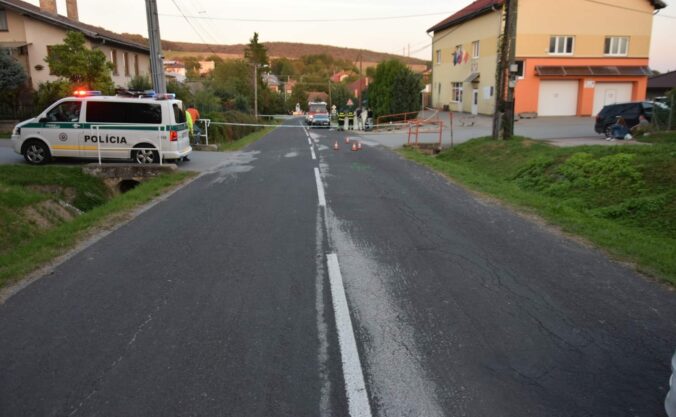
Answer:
87, 101, 162, 124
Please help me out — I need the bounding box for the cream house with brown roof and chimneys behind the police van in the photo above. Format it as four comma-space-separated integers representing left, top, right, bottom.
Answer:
0, 0, 150, 89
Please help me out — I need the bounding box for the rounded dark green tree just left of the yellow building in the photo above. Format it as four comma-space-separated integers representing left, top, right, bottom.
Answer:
369, 59, 423, 115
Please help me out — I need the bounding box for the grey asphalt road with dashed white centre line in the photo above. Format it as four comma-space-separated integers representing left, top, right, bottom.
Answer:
0, 121, 676, 417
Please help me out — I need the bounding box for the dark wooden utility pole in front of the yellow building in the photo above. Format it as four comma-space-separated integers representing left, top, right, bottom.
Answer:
493, 0, 518, 139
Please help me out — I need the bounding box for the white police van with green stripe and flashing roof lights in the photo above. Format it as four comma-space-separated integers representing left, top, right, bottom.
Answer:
12, 90, 192, 165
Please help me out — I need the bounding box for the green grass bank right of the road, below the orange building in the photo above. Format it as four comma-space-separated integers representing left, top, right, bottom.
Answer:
401, 134, 676, 284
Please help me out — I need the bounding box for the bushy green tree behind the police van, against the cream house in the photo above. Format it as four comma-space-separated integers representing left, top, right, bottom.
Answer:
45, 32, 115, 93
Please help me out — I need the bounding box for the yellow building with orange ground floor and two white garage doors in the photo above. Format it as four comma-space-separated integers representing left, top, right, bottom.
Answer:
428, 0, 666, 116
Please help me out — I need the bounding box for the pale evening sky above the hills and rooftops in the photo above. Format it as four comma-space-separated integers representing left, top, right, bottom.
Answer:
35, 0, 676, 72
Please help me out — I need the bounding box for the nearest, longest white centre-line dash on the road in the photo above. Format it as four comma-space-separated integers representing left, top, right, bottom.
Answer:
326, 254, 371, 417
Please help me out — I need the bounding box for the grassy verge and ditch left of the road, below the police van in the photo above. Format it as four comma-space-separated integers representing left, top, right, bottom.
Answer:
0, 166, 194, 288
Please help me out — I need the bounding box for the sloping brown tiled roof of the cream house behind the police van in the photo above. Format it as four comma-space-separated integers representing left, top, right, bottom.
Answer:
0, 0, 150, 53
